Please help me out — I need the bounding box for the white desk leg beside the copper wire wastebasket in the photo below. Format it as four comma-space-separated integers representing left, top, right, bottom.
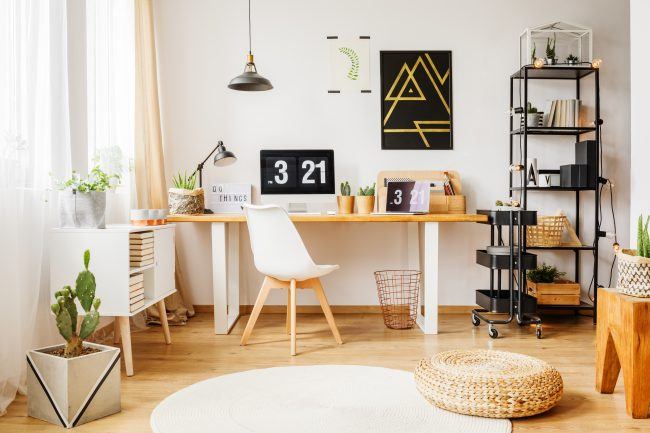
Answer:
418, 222, 439, 334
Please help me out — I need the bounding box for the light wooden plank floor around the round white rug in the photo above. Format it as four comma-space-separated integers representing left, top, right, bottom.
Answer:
0, 314, 650, 433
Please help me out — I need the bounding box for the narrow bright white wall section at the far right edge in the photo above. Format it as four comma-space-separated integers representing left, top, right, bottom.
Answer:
630, 0, 650, 243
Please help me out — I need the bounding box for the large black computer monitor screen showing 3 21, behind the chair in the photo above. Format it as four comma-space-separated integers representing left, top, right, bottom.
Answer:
260, 149, 334, 194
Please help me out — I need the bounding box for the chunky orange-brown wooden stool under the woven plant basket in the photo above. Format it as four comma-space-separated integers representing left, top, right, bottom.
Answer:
596, 288, 650, 418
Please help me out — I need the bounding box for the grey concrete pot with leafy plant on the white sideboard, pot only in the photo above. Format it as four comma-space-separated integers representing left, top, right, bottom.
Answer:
59, 190, 106, 229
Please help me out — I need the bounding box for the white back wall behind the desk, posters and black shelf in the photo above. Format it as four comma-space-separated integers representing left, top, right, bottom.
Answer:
155, 0, 630, 305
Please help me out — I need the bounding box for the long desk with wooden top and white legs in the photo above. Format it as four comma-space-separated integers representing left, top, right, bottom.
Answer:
168, 214, 487, 334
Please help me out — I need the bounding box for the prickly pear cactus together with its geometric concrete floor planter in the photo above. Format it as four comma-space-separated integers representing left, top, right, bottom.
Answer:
27, 250, 121, 428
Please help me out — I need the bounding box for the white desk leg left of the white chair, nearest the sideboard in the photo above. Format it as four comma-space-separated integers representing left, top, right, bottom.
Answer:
212, 222, 239, 334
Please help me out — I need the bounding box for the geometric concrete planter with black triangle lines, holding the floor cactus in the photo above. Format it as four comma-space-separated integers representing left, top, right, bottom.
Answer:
27, 342, 121, 428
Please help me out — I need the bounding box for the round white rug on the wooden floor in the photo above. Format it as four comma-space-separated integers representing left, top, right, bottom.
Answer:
151, 365, 511, 433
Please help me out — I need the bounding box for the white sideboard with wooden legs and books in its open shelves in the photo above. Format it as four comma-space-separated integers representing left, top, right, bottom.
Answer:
50, 224, 176, 376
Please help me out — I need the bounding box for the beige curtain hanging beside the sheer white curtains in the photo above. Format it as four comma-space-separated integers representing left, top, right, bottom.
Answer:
134, 0, 194, 324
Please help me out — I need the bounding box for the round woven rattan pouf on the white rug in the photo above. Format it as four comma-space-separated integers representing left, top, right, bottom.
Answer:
415, 350, 562, 418
